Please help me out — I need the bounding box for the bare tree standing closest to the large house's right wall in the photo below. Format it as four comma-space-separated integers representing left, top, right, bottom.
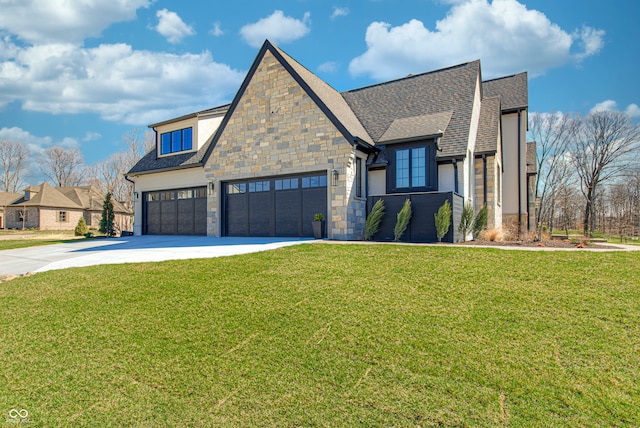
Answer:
529, 113, 576, 238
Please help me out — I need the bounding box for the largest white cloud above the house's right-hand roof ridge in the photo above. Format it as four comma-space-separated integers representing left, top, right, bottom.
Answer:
349, 0, 604, 79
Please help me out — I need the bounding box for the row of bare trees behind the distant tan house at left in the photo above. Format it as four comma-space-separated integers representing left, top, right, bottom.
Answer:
0, 129, 154, 206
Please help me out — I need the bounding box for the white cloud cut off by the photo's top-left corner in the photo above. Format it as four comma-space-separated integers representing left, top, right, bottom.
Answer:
0, 0, 151, 44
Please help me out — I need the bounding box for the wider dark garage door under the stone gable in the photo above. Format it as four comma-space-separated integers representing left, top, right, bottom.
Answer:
223, 173, 327, 237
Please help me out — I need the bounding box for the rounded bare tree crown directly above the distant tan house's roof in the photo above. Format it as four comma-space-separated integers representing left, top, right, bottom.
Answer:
38, 146, 84, 187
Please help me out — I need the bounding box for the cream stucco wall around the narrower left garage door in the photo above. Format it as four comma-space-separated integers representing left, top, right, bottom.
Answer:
129, 167, 207, 235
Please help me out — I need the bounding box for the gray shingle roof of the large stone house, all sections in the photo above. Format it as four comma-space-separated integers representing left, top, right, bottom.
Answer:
128, 42, 528, 175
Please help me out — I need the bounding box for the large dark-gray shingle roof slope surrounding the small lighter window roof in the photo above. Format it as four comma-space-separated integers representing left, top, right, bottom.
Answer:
342, 61, 480, 157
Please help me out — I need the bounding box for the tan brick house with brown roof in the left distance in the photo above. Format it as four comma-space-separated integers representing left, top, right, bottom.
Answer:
5, 183, 133, 231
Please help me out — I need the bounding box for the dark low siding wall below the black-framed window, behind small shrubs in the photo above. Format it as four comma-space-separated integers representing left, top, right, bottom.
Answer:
367, 192, 463, 242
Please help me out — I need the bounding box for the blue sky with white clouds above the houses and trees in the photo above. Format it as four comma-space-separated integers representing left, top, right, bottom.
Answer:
0, 0, 640, 178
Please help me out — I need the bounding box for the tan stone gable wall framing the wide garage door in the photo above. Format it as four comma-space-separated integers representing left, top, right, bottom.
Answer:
205, 51, 366, 239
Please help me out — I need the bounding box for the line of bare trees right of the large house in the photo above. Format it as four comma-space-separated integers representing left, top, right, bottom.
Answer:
529, 111, 640, 237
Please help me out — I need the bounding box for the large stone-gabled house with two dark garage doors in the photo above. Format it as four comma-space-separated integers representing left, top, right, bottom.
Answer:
127, 41, 528, 242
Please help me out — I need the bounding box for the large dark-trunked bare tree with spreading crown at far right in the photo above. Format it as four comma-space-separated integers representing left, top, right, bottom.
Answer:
572, 111, 640, 236
